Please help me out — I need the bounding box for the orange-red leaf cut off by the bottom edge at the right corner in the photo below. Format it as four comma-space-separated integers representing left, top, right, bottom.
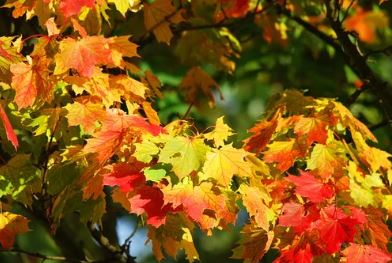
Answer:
343, 243, 392, 263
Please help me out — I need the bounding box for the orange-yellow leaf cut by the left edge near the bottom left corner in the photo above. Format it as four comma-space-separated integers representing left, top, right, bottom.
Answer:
0, 212, 29, 249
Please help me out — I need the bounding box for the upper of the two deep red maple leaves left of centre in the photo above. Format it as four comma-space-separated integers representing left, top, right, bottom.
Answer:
103, 163, 146, 193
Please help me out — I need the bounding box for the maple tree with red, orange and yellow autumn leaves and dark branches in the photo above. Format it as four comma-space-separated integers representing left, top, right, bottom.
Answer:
0, 0, 392, 262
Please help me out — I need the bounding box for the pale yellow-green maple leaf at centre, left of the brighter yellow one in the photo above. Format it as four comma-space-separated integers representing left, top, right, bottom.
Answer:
158, 136, 208, 179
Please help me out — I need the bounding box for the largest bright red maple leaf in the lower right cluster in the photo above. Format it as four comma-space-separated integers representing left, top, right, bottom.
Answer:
312, 205, 358, 254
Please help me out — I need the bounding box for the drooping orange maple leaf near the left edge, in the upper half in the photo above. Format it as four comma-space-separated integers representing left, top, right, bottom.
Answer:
10, 57, 52, 109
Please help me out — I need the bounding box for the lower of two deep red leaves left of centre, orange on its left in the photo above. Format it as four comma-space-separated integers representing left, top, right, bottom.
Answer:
129, 186, 174, 227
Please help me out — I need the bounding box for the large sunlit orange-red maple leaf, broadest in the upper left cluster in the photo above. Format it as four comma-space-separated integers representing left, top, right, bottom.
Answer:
54, 36, 112, 77
